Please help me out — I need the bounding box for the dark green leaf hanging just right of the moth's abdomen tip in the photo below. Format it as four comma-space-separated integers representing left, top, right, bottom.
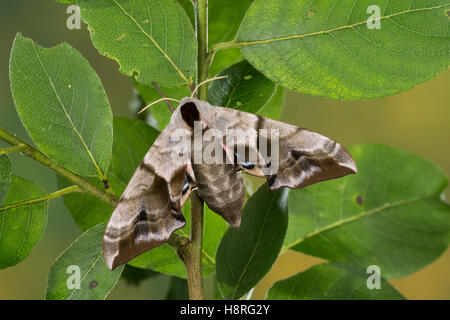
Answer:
216, 184, 288, 299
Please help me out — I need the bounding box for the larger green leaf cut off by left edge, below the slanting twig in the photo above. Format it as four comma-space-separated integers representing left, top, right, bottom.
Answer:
0, 175, 49, 269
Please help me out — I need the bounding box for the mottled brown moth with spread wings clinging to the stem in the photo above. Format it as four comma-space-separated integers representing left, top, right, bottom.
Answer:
103, 98, 356, 269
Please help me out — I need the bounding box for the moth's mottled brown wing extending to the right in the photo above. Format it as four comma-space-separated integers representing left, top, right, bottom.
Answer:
195, 102, 357, 189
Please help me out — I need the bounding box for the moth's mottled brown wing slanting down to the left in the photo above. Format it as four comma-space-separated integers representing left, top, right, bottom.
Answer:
103, 120, 194, 269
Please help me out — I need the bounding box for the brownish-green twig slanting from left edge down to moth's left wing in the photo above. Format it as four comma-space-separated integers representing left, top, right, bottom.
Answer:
0, 128, 117, 206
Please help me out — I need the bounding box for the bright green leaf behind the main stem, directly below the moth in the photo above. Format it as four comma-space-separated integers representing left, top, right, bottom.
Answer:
129, 201, 228, 278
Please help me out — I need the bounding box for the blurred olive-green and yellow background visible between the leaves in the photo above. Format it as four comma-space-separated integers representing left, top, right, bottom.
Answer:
0, 0, 450, 299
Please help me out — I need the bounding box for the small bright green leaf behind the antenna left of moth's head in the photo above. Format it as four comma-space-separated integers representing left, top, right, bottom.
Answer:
134, 81, 191, 130
